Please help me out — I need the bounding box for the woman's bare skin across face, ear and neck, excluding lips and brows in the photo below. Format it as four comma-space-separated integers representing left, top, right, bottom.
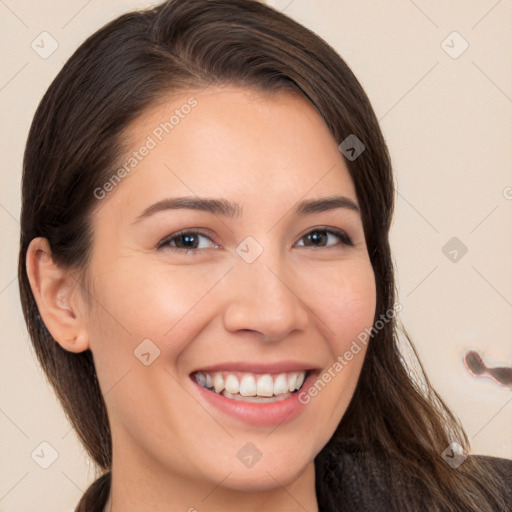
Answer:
27, 87, 376, 512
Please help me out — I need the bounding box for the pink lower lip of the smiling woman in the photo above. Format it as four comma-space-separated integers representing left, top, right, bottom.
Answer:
191, 373, 316, 427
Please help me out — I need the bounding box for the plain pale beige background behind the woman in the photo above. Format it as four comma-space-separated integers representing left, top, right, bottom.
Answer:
0, 0, 512, 512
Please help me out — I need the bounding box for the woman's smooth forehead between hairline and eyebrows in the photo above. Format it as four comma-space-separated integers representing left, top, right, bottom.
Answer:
97, 83, 356, 218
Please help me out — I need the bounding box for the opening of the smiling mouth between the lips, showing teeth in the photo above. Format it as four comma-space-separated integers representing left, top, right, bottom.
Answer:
191, 370, 313, 403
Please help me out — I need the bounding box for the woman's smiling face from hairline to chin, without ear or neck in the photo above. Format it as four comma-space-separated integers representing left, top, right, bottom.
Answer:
82, 87, 376, 491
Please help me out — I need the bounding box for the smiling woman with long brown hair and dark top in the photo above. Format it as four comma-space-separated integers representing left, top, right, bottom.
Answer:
19, 0, 512, 512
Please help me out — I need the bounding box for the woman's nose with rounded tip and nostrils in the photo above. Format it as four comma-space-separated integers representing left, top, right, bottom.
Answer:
223, 258, 309, 341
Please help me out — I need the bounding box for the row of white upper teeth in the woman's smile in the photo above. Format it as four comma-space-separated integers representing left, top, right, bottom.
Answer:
195, 371, 306, 397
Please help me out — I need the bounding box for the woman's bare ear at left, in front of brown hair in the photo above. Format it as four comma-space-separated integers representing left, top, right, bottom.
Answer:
26, 237, 89, 352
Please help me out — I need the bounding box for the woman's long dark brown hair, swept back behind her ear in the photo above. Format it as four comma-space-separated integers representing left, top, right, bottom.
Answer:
18, 0, 505, 512
